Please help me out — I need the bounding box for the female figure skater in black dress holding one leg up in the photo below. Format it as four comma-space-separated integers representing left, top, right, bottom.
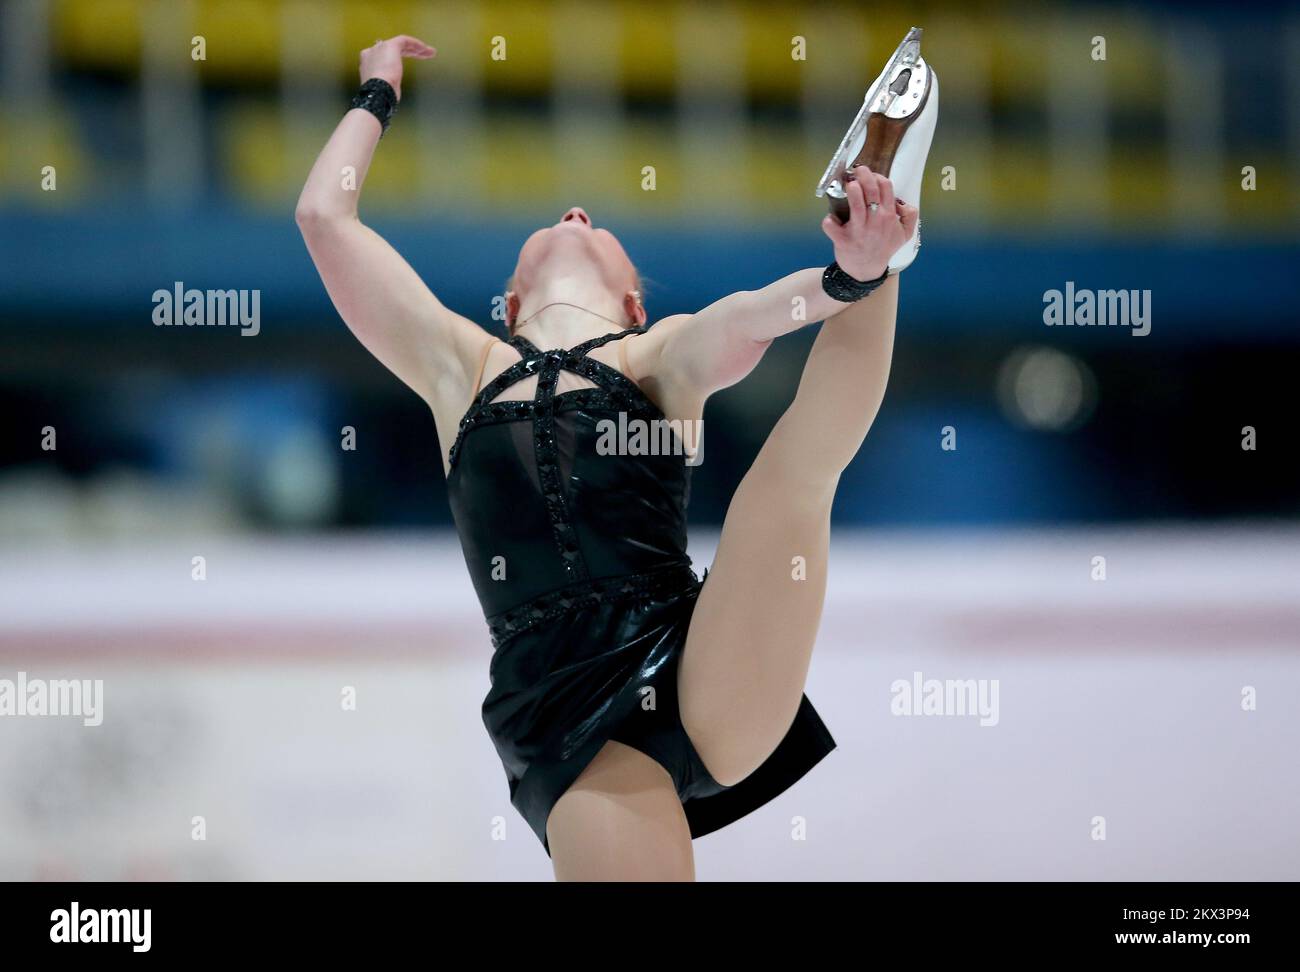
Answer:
296, 36, 932, 880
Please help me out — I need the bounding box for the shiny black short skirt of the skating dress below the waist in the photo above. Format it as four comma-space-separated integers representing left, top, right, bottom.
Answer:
482, 567, 835, 855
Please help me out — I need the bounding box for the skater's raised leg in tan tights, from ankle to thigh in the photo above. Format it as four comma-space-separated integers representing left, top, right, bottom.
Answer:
679, 277, 898, 786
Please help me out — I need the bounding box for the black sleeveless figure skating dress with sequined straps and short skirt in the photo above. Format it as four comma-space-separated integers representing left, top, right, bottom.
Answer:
447, 327, 835, 855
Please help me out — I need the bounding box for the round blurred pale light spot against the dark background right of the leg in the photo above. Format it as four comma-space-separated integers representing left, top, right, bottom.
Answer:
997, 347, 1097, 431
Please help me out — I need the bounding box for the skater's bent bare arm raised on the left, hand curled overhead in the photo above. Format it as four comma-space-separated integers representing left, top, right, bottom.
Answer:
295, 35, 485, 418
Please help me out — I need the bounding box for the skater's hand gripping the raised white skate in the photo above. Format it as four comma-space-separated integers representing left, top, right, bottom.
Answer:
822, 165, 917, 281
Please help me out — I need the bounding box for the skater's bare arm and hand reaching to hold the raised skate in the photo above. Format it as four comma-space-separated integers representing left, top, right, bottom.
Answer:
628, 166, 917, 396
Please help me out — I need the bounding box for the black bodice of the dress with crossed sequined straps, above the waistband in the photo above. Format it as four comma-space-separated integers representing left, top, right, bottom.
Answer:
447, 329, 690, 631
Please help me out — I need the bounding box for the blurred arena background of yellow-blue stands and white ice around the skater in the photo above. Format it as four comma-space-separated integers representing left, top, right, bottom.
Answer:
0, 0, 1300, 880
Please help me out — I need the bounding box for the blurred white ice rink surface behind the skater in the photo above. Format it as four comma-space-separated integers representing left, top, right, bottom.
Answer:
0, 526, 1300, 880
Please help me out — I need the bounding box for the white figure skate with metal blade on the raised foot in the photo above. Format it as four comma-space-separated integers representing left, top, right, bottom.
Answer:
816, 27, 939, 273
